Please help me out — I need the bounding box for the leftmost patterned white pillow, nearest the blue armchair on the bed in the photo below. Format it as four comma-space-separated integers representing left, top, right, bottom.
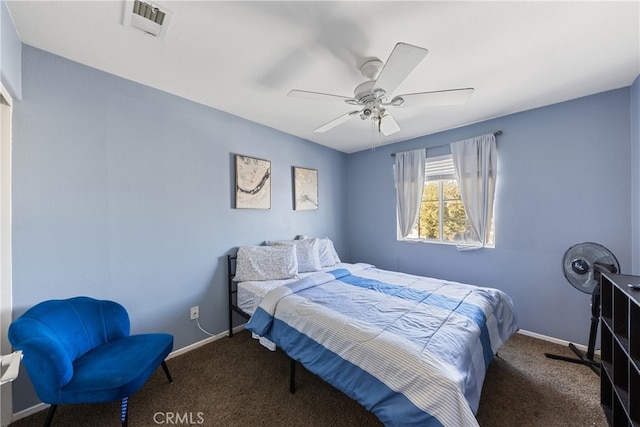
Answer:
233, 246, 298, 282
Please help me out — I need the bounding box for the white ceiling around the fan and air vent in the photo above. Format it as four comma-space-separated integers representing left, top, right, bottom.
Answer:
7, 0, 640, 153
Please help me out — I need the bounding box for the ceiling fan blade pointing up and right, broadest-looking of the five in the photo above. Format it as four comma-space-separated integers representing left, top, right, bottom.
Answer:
373, 43, 429, 94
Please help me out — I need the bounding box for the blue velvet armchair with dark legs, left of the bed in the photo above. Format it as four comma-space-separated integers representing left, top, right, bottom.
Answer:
9, 297, 173, 426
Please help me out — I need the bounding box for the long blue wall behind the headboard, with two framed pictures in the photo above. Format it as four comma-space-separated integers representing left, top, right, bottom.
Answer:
13, 46, 348, 410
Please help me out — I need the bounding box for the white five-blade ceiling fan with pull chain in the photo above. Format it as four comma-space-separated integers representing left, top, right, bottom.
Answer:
288, 43, 473, 136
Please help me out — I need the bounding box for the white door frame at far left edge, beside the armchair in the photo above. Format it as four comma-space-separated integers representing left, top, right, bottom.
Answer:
0, 82, 13, 427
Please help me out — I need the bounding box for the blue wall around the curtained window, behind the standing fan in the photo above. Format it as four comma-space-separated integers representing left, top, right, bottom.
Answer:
347, 88, 631, 344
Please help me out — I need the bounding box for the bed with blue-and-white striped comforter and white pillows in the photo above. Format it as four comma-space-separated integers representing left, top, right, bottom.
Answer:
229, 239, 518, 426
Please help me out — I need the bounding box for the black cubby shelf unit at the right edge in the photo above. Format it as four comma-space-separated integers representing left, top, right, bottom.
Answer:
600, 273, 640, 427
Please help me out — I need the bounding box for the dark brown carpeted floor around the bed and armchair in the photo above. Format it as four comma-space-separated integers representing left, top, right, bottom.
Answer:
11, 331, 607, 427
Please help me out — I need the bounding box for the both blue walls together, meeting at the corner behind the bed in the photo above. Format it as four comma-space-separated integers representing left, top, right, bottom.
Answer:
6, 26, 640, 411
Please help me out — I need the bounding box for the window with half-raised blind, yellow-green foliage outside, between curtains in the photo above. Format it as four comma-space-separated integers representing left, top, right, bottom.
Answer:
407, 154, 493, 246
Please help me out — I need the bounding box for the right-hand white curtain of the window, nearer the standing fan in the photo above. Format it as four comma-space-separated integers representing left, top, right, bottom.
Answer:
451, 133, 497, 250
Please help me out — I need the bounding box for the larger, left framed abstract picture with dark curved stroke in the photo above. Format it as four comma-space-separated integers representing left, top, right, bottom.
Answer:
236, 154, 271, 209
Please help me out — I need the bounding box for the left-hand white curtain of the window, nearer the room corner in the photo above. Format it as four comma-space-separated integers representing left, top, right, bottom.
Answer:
394, 148, 427, 238
